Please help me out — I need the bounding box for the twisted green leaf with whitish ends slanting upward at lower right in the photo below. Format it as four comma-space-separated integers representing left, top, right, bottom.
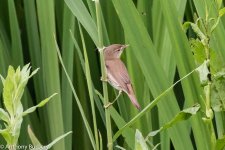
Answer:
148, 104, 200, 137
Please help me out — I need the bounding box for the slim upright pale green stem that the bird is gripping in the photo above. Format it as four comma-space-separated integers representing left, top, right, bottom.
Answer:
95, 0, 113, 150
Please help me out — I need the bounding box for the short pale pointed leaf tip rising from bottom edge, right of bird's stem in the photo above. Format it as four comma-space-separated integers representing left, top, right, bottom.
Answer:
135, 129, 149, 150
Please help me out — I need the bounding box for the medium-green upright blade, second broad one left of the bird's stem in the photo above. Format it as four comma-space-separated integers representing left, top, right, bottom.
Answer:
61, 4, 75, 149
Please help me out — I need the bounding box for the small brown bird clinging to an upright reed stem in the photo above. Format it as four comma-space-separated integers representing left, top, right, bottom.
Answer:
103, 44, 140, 109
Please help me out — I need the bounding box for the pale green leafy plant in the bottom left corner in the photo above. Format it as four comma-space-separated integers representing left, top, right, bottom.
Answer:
0, 64, 70, 149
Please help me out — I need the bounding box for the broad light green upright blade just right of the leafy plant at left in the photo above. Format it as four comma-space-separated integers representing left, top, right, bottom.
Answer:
36, 0, 65, 150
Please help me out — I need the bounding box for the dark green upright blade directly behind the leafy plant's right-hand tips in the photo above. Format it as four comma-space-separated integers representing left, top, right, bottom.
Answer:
24, 0, 47, 141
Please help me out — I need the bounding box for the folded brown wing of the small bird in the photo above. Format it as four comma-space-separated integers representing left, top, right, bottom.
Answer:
105, 59, 130, 93
